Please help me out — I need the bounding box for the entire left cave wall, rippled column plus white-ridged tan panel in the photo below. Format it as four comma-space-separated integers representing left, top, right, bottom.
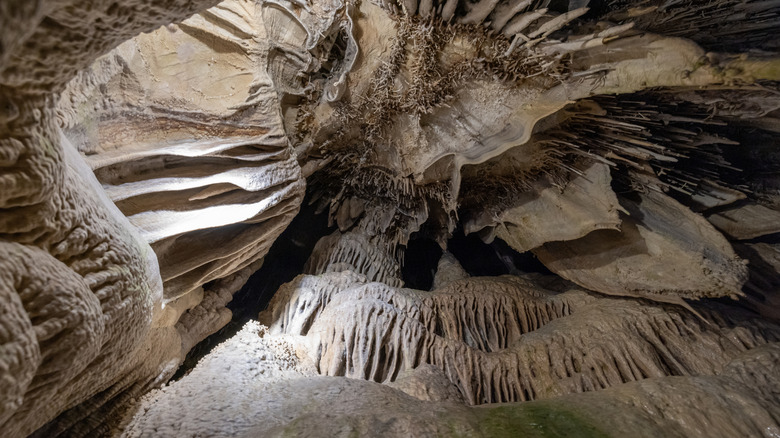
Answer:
0, 1, 303, 437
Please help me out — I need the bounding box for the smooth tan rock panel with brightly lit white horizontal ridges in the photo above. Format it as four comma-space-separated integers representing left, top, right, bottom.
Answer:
59, 0, 304, 302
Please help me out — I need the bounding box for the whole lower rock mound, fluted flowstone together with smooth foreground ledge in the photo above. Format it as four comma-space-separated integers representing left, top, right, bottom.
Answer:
124, 273, 780, 437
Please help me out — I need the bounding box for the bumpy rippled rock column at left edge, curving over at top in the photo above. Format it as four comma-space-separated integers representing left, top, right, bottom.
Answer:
0, 1, 300, 437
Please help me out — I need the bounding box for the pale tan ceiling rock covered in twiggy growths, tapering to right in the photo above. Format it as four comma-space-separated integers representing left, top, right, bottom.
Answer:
295, 6, 771, 185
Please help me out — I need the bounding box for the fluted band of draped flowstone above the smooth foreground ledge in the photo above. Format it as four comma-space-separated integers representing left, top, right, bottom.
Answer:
260, 273, 780, 404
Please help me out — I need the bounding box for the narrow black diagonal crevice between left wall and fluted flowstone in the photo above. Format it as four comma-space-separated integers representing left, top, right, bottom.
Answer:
171, 197, 334, 380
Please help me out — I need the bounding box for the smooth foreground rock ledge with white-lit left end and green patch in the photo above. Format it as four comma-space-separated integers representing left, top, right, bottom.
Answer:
122, 274, 780, 437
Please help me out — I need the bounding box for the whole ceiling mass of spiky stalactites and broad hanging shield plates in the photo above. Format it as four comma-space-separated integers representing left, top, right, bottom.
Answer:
279, 1, 780, 303
